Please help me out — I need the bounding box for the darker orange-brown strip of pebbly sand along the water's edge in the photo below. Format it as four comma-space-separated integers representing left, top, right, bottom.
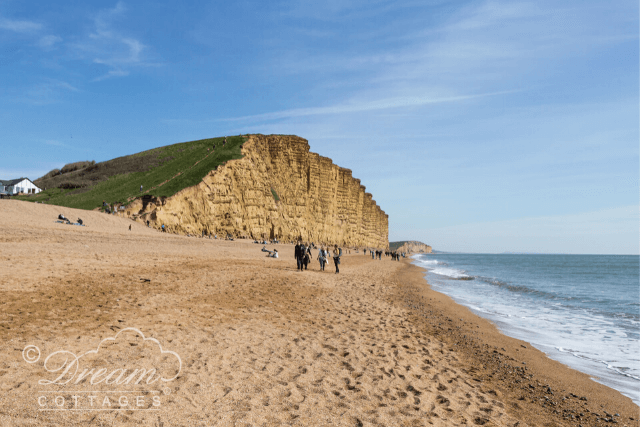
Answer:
396, 261, 639, 426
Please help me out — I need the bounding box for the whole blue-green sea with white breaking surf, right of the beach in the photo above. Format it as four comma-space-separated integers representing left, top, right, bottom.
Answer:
412, 253, 640, 404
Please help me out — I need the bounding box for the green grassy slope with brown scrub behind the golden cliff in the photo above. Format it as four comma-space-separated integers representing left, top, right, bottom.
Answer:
16, 136, 246, 209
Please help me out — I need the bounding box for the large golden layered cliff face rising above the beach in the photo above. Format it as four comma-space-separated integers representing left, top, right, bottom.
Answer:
126, 135, 389, 248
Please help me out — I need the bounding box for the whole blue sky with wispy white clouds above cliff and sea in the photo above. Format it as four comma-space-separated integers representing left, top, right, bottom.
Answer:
0, 0, 640, 254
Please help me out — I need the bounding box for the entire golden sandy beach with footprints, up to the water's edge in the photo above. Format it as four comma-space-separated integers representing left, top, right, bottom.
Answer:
0, 200, 638, 426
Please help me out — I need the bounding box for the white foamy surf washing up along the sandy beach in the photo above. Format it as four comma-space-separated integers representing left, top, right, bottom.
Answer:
417, 259, 640, 403
